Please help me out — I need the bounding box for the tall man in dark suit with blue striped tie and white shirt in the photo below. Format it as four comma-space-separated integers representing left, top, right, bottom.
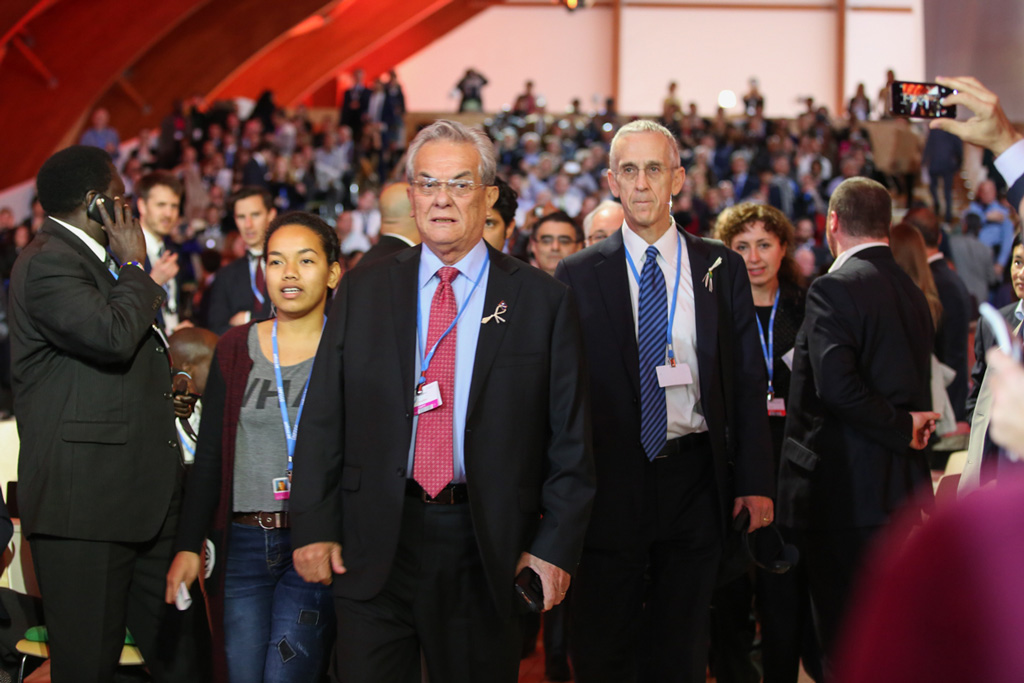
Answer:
555, 121, 774, 683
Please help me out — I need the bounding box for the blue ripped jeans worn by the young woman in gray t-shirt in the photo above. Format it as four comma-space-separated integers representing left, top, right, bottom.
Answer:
224, 523, 335, 683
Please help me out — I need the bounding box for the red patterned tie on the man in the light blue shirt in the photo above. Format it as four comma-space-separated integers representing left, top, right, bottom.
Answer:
413, 266, 459, 498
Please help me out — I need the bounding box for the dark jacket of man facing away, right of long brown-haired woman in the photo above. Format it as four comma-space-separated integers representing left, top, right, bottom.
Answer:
931, 259, 972, 422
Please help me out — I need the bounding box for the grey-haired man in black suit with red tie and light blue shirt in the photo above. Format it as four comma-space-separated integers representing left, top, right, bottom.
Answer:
291, 121, 594, 683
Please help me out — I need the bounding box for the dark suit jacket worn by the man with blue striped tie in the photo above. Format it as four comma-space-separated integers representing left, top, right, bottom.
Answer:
555, 228, 774, 549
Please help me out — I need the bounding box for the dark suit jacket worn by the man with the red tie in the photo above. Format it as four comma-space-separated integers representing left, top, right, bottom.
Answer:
290, 242, 594, 615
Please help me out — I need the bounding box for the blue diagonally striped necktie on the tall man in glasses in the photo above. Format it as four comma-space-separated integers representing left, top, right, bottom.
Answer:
637, 246, 669, 460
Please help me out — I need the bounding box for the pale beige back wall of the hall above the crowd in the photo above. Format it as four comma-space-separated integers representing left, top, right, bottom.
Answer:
397, 0, 925, 116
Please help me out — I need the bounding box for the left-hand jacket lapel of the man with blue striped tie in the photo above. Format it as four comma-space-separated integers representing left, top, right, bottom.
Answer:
594, 228, 640, 396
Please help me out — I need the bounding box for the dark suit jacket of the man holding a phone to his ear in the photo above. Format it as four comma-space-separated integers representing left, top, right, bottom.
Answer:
10, 220, 181, 542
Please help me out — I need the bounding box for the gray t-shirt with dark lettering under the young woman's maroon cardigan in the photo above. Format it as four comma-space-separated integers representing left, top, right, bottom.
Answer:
232, 325, 313, 512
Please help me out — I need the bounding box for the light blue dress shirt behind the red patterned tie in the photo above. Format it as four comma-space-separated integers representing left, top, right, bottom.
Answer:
408, 240, 490, 483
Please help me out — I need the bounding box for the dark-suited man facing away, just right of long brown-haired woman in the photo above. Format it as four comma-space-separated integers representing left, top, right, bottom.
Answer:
904, 207, 973, 422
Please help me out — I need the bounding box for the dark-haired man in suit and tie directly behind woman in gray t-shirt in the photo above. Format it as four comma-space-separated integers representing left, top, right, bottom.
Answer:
204, 186, 278, 335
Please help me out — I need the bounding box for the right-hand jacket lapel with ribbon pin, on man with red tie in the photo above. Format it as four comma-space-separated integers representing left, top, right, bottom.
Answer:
468, 247, 528, 420
